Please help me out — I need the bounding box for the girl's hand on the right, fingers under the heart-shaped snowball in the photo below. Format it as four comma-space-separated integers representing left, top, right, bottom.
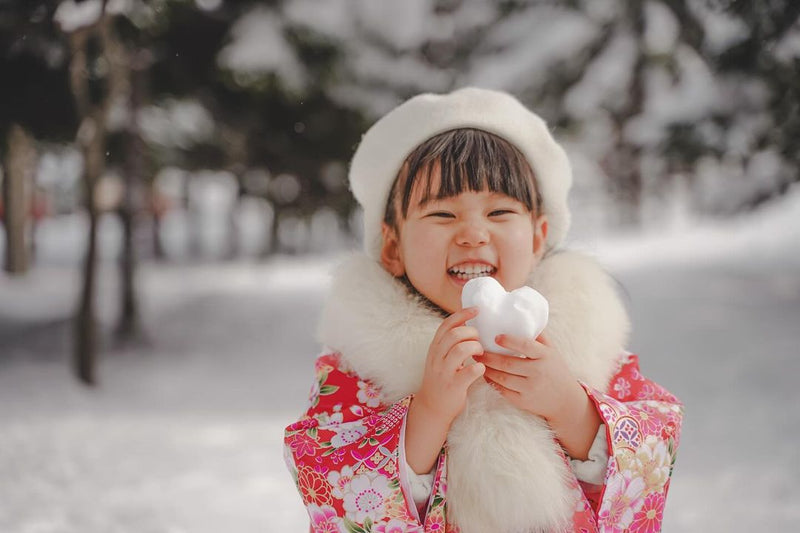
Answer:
475, 335, 587, 429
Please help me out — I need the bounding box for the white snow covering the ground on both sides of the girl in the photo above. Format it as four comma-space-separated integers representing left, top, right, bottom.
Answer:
0, 188, 800, 533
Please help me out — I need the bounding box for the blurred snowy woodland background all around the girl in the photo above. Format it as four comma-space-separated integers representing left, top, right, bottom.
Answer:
0, 0, 800, 533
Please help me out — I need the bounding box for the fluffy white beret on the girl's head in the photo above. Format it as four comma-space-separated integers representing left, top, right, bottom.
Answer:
349, 87, 572, 259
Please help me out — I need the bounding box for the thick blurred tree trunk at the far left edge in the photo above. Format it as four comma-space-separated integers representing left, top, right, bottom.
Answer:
3, 124, 36, 274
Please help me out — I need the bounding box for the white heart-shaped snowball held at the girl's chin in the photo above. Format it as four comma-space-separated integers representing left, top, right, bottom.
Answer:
461, 276, 550, 355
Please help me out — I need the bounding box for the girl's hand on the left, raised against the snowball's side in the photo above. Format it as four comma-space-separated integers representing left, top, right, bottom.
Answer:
414, 307, 486, 428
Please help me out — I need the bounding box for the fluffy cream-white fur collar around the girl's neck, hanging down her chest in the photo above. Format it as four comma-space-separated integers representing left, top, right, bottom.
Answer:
319, 252, 629, 533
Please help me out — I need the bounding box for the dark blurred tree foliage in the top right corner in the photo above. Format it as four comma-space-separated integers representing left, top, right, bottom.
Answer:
708, 0, 800, 211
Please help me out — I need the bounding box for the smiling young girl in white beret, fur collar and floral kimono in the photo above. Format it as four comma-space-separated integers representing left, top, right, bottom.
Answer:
285, 88, 682, 533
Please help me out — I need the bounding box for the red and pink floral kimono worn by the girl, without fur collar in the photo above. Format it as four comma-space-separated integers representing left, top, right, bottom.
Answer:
284, 353, 683, 533
